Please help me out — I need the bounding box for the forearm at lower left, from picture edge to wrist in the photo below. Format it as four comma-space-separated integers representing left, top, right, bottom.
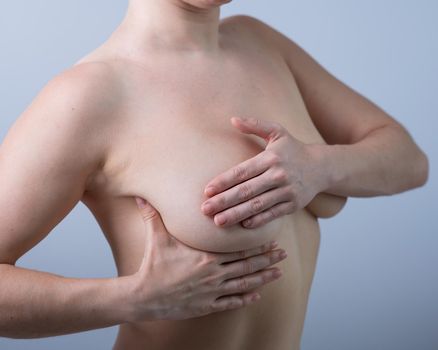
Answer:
0, 265, 130, 338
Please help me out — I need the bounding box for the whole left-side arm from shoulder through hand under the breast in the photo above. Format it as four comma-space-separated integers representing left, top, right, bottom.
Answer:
0, 64, 286, 338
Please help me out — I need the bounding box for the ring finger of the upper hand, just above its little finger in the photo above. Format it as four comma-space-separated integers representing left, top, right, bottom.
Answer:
214, 188, 290, 227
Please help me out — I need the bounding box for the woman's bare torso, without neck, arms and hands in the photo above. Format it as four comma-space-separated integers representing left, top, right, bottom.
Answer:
76, 18, 335, 350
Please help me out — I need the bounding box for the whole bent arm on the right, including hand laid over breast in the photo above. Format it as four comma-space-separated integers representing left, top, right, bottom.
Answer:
201, 15, 428, 228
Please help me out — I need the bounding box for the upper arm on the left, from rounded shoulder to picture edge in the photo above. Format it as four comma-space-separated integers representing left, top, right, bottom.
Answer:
0, 63, 114, 264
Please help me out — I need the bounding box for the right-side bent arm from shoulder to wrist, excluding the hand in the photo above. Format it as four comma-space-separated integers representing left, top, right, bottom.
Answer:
269, 21, 428, 197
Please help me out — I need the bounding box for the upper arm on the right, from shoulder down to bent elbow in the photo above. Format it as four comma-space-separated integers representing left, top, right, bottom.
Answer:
236, 16, 401, 144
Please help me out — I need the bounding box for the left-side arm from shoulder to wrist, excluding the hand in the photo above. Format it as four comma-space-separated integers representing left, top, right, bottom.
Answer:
0, 66, 133, 338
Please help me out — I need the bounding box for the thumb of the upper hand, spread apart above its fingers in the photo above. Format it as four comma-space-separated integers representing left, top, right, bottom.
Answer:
231, 117, 284, 142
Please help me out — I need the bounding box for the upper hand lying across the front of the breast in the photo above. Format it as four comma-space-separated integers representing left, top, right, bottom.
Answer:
201, 117, 327, 228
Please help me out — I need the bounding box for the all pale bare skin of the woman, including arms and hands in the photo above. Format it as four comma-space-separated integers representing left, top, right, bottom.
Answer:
0, 0, 428, 349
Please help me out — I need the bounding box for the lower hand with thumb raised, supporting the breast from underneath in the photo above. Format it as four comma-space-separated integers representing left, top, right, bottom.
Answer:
126, 197, 286, 322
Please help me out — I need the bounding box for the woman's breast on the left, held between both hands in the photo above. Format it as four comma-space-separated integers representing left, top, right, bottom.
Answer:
102, 113, 292, 252
